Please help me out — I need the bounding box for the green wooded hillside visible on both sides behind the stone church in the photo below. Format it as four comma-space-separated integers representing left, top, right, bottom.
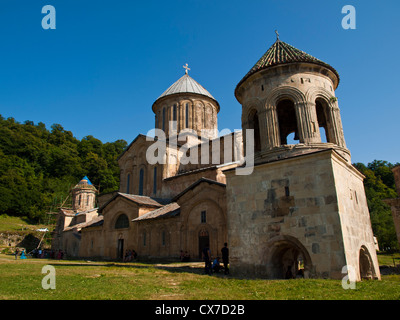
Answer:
0, 115, 398, 249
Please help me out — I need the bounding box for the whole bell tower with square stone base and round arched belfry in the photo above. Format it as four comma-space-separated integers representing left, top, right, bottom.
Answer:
225, 37, 380, 281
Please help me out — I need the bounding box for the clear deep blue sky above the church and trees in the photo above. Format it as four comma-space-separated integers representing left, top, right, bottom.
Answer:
0, 0, 400, 163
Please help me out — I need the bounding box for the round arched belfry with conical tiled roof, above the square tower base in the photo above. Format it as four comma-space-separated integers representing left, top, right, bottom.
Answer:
235, 37, 350, 162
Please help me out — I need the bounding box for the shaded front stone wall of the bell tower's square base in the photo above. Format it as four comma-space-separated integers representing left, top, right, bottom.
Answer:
226, 150, 379, 279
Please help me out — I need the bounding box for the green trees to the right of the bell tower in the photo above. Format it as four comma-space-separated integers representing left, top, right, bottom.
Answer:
354, 160, 399, 250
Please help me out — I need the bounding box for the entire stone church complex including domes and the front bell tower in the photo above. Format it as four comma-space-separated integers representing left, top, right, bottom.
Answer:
53, 37, 380, 281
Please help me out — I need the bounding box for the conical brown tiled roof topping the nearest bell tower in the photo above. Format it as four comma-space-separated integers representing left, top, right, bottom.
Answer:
236, 39, 339, 88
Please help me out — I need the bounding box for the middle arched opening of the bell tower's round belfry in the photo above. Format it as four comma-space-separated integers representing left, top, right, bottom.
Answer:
276, 99, 299, 145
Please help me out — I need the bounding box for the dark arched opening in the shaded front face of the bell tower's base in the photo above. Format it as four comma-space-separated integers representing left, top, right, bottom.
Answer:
265, 236, 312, 279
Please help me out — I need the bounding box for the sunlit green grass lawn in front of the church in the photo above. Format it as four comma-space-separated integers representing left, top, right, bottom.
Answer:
0, 254, 400, 300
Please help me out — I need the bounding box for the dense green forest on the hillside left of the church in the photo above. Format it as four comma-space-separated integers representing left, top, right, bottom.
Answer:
0, 115, 127, 221
